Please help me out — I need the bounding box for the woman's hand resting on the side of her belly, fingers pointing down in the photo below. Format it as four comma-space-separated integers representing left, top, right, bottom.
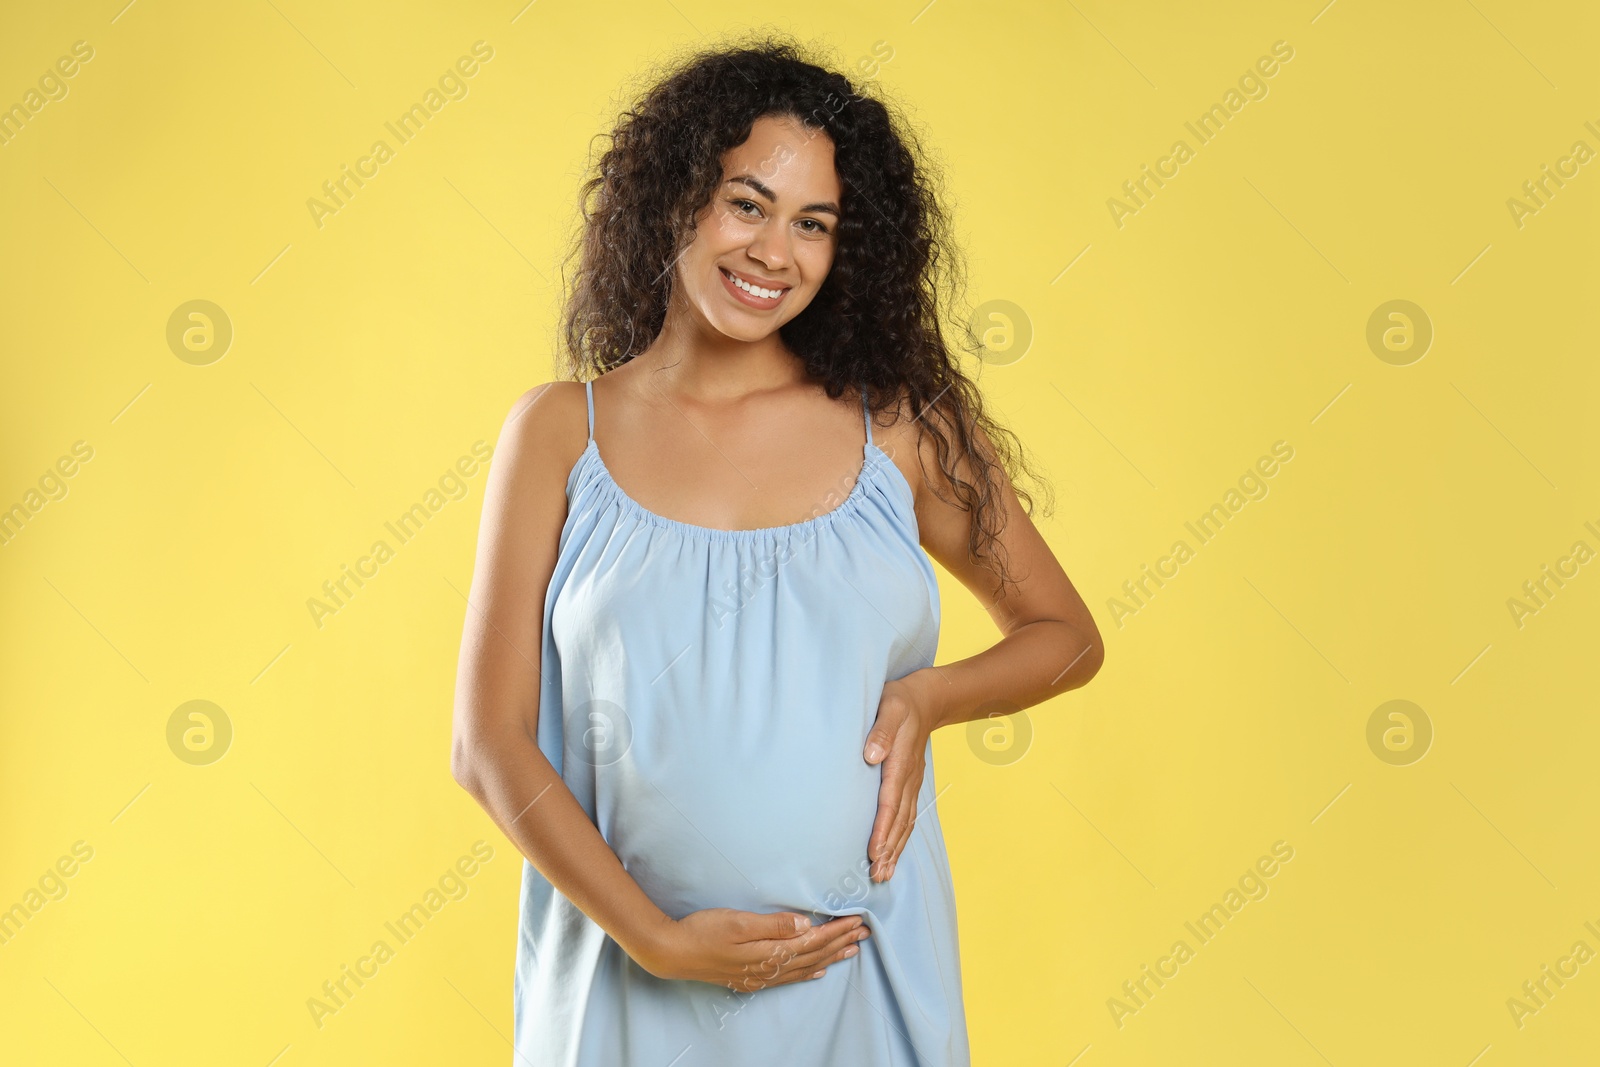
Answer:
862, 672, 933, 881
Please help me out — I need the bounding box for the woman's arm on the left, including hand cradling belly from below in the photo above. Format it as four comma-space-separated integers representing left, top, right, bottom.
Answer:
450, 382, 859, 987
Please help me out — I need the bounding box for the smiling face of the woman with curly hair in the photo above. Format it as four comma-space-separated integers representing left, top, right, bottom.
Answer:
677, 115, 842, 341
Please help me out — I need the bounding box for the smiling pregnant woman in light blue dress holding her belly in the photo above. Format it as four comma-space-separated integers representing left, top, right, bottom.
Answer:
451, 42, 1102, 1067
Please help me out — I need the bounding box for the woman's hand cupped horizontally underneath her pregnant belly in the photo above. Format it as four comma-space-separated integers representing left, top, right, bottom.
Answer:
634, 907, 870, 992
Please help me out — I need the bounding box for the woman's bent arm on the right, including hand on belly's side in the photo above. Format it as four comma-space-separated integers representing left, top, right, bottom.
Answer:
862, 412, 1106, 881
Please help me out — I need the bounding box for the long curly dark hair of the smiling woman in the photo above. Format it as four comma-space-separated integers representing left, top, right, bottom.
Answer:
560, 34, 1050, 597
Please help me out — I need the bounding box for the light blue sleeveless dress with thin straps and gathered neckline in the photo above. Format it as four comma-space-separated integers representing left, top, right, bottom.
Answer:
514, 382, 970, 1067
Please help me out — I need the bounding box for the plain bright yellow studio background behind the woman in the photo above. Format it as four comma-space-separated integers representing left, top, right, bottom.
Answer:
0, 0, 1600, 1067
